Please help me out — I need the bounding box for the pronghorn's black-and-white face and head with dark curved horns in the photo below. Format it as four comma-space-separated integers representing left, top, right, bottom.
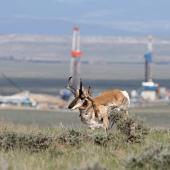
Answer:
67, 77, 92, 110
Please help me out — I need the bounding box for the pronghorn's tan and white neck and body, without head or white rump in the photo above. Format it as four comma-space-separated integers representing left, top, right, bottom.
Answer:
68, 89, 127, 129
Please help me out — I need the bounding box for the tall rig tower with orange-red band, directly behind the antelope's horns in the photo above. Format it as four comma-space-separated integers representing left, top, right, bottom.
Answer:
71, 27, 82, 89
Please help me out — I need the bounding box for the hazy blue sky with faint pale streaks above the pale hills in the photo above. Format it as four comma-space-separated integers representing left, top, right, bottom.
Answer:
0, 0, 170, 36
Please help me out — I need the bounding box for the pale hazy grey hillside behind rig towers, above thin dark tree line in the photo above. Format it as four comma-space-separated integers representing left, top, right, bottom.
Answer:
0, 34, 170, 64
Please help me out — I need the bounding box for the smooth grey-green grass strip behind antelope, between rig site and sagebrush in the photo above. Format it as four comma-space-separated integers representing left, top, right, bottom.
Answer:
0, 105, 170, 128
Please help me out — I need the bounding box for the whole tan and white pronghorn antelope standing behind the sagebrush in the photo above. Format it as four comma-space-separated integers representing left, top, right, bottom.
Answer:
67, 77, 130, 129
